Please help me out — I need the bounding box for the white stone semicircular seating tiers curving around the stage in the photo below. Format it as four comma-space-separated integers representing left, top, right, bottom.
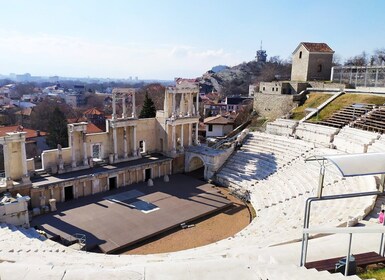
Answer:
0, 130, 375, 279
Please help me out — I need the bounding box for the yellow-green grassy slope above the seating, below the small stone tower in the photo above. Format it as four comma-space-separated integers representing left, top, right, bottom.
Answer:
293, 93, 385, 121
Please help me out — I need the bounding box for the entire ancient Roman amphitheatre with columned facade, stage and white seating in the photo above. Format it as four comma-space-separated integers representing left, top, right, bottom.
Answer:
0, 43, 385, 280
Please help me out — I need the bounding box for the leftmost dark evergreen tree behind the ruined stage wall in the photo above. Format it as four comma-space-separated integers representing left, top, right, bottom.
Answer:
47, 107, 68, 148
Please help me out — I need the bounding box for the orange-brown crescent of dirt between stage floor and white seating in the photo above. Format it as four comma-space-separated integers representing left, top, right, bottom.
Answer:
122, 187, 251, 255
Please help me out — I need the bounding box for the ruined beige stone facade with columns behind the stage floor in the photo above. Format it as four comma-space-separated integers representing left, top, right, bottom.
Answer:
0, 79, 199, 213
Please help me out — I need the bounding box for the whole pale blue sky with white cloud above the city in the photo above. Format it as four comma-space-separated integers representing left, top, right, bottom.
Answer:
0, 0, 385, 80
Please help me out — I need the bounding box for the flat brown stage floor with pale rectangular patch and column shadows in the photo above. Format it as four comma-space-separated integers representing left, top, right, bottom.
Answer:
31, 174, 232, 253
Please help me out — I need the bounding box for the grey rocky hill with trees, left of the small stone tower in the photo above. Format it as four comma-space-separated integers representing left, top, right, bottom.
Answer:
198, 57, 291, 96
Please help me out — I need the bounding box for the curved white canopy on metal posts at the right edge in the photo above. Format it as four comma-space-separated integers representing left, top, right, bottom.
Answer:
306, 153, 385, 177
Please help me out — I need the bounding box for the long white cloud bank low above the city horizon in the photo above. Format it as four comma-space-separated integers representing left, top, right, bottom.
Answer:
0, 30, 238, 79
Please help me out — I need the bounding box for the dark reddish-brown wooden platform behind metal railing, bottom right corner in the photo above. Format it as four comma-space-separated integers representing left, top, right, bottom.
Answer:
305, 252, 385, 272
